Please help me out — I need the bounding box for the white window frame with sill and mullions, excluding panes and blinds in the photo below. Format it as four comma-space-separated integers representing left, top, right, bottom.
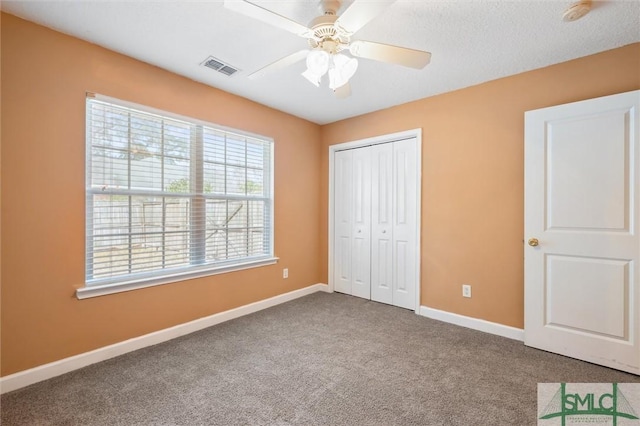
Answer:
76, 92, 278, 299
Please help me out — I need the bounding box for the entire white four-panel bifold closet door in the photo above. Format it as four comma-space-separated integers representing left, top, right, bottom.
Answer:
333, 138, 420, 309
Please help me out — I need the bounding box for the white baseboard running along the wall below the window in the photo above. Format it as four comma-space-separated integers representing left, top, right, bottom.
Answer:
0, 284, 329, 394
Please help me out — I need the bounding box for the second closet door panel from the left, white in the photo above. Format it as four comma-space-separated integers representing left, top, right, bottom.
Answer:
351, 148, 371, 299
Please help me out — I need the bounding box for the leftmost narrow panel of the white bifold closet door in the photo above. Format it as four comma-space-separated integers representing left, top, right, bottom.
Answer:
333, 151, 353, 294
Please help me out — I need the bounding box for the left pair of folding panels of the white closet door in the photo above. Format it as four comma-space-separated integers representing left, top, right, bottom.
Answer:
334, 149, 371, 299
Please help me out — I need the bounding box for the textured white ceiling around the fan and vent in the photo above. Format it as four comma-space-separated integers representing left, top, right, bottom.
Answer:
1, 0, 640, 124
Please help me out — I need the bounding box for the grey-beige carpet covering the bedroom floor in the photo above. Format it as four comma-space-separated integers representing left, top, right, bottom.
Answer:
0, 293, 640, 426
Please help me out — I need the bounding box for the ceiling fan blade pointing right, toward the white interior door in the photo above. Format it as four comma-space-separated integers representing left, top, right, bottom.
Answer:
349, 40, 431, 69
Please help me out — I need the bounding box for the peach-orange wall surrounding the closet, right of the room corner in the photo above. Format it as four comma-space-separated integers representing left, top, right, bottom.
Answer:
320, 43, 640, 328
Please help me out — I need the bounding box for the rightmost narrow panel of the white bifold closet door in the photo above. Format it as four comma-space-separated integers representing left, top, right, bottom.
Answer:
393, 138, 420, 309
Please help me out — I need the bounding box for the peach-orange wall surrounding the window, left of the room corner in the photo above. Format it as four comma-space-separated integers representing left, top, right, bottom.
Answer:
1, 13, 321, 376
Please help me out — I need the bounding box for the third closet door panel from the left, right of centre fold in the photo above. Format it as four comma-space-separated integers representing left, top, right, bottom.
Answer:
370, 143, 393, 305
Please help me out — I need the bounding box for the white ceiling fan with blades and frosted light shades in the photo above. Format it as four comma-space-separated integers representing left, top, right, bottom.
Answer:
224, 0, 431, 98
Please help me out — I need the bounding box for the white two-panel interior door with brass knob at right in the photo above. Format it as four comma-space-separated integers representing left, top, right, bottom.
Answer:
525, 91, 640, 374
